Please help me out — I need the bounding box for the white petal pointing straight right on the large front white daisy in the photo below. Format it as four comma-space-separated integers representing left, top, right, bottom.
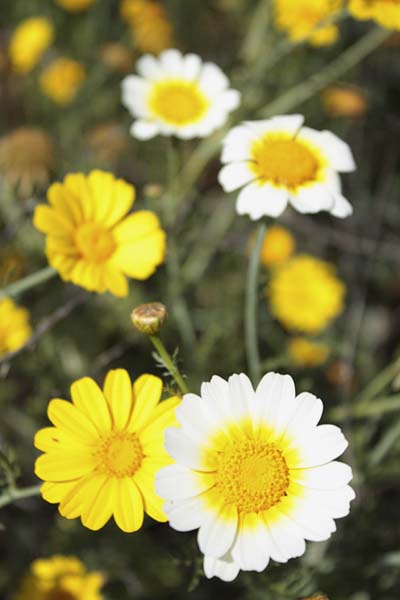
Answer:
290, 461, 353, 490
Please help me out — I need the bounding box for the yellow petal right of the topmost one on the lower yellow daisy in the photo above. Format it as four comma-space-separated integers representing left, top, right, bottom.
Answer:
128, 375, 162, 431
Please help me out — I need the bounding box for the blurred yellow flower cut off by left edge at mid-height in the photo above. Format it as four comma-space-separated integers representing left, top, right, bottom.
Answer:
0, 298, 32, 356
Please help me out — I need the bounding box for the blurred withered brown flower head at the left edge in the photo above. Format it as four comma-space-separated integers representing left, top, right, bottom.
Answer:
0, 127, 54, 196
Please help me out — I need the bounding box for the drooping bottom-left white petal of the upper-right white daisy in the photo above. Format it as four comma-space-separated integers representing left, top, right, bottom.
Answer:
236, 182, 288, 221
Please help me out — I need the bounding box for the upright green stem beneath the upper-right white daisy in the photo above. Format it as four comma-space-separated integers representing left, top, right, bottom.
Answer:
244, 223, 267, 385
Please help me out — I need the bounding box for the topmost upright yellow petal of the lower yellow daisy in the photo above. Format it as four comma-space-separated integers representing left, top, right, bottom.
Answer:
104, 369, 133, 429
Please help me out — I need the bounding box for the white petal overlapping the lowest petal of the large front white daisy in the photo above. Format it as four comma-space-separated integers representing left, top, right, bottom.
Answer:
197, 505, 238, 558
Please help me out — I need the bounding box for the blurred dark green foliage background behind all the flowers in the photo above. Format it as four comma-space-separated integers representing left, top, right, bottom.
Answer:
0, 0, 400, 600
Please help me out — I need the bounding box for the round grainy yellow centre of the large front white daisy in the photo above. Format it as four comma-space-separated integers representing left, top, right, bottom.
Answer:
216, 440, 289, 513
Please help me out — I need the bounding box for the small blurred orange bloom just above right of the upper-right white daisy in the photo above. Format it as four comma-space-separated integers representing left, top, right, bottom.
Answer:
321, 85, 367, 117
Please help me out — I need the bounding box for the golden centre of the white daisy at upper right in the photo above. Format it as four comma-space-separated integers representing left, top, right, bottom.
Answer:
252, 133, 320, 188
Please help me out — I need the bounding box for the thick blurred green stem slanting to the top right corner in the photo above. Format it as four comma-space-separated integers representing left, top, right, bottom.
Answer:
260, 27, 391, 118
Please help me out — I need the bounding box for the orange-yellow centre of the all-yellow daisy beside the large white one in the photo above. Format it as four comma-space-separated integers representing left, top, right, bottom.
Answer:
95, 431, 143, 479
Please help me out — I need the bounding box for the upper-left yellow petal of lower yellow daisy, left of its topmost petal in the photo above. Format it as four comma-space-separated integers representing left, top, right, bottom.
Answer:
71, 377, 112, 433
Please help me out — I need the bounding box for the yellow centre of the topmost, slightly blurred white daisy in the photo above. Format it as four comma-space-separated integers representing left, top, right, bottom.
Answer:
149, 80, 209, 126
